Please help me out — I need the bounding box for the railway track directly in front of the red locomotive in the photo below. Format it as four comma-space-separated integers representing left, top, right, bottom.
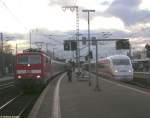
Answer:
0, 93, 38, 118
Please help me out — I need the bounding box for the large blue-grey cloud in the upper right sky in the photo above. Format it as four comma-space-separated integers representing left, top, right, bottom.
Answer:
102, 0, 150, 26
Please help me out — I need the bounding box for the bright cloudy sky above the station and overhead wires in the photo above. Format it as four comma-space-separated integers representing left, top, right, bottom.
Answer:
0, 0, 150, 57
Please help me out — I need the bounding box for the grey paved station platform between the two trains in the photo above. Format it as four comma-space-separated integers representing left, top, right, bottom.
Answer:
29, 71, 150, 118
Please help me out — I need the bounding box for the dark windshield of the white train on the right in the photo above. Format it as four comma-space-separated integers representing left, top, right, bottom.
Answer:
112, 59, 130, 65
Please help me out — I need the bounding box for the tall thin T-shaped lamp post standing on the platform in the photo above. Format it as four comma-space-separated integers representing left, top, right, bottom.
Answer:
82, 9, 95, 86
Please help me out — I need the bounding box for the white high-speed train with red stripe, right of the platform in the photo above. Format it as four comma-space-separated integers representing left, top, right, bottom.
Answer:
85, 55, 133, 81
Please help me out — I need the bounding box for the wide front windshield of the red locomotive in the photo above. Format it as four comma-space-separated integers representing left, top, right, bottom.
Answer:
18, 55, 41, 64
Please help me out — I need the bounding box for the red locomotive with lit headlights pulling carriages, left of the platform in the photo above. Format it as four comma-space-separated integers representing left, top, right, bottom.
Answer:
14, 49, 65, 89
